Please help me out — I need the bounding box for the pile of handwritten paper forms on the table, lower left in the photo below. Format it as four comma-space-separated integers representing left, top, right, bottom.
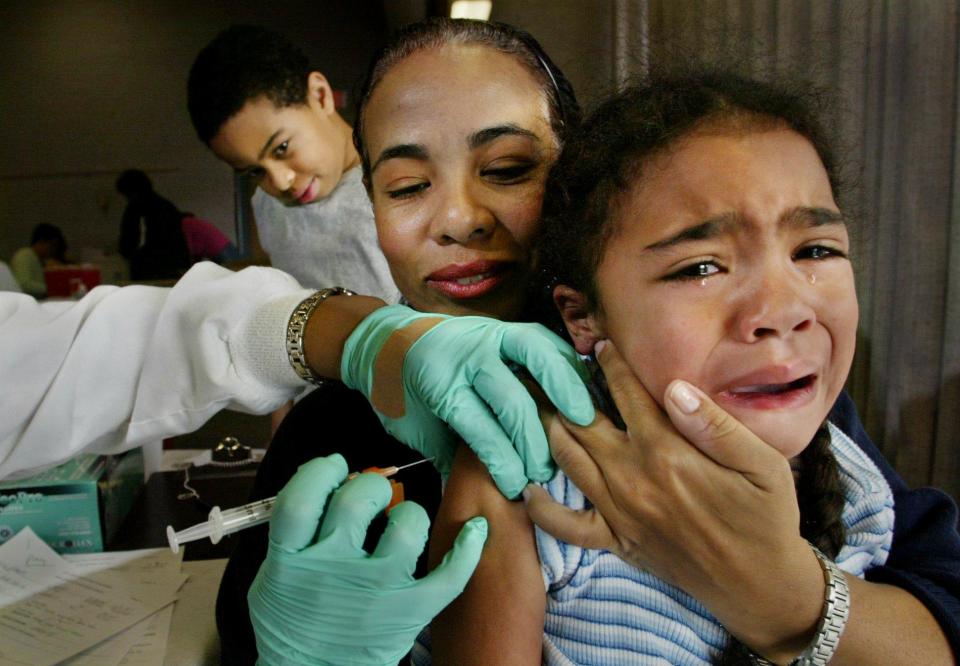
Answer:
0, 528, 185, 666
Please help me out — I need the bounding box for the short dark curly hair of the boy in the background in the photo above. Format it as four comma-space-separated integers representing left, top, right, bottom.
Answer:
187, 25, 312, 144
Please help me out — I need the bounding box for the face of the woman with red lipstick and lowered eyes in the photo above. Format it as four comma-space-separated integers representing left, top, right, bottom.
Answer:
363, 45, 558, 319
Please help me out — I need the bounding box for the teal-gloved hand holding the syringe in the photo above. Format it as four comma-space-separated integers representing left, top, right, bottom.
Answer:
247, 455, 487, 666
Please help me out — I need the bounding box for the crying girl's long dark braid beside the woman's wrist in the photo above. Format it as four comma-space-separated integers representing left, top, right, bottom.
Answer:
714, 423, 846, 666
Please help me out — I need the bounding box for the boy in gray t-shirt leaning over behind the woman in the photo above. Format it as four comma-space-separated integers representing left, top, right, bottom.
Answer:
187, 26, 400, 303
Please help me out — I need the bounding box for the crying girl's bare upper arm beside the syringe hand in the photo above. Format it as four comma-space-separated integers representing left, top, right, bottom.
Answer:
430, 446, 546, 664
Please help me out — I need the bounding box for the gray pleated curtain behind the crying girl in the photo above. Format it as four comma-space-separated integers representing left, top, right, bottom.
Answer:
612, 0, 960, 498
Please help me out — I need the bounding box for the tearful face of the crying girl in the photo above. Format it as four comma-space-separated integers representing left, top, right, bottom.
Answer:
572, 128, 857, 458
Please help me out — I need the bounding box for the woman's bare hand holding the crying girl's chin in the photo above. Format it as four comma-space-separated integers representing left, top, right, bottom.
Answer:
524, 344, 823, 655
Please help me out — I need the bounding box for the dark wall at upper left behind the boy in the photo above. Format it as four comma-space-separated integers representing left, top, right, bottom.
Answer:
0, 0, 385, 270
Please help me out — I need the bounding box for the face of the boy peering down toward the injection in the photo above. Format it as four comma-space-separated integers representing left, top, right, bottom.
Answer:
210, 72, 357, 206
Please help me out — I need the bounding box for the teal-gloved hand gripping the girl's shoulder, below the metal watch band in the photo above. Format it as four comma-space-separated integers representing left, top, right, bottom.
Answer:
340, 305, 594, 498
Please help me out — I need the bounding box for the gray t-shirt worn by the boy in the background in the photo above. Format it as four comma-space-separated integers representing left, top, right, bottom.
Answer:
253, 166, 400, 303
